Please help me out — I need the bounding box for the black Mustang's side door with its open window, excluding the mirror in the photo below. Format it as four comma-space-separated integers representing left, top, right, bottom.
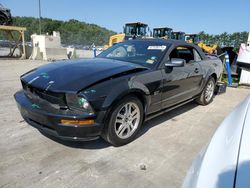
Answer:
162, 46, 202, 108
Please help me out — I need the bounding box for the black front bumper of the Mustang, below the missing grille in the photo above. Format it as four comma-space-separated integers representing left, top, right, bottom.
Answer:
14, 91, 105, 141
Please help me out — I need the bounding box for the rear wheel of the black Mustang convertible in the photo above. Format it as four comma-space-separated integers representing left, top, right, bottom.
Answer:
196, 77, 215, 106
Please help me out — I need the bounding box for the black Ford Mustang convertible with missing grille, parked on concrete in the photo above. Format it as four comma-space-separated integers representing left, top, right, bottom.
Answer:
15, 39, 222, 146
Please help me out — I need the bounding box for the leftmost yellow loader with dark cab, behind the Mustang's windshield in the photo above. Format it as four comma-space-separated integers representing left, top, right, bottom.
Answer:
104, 22, 149, 49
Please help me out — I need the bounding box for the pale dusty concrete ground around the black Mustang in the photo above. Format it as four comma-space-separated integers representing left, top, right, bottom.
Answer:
0, 59, 250, 188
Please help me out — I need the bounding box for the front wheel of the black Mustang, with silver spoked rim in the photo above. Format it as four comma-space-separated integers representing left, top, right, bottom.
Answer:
102, 96, 143, 146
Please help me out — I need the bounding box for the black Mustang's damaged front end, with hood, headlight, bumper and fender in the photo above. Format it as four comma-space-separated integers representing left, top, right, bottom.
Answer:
15, 58, 147, 140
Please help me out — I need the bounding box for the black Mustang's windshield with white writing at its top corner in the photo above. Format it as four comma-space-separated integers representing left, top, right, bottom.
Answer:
97, 40, 168, 67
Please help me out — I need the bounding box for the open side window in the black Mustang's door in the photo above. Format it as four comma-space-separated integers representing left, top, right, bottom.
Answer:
169, 46, 195, 63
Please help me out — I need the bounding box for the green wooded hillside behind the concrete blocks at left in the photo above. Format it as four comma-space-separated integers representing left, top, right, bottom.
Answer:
4, 17, 115, 45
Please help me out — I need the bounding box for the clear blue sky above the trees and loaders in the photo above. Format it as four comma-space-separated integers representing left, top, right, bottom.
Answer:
0, 0, 250, 34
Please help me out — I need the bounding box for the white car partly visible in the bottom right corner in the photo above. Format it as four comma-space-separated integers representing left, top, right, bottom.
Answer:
182, 95, 250, 188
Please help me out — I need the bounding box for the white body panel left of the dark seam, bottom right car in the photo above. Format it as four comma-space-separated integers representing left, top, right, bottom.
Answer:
182, 95, 250, 188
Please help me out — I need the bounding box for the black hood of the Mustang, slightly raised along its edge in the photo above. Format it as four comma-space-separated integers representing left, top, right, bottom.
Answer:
21, 58, 146, 92
